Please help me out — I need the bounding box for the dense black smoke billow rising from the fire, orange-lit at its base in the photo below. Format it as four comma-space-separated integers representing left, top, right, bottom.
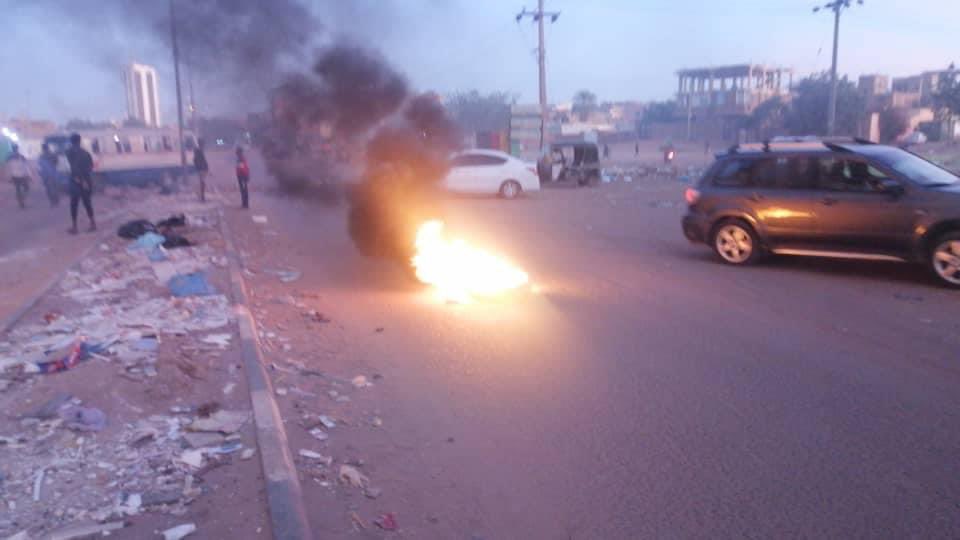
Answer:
263, 45, 460, 260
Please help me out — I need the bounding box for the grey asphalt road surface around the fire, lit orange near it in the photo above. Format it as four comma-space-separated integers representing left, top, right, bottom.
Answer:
221, 160, 960, 539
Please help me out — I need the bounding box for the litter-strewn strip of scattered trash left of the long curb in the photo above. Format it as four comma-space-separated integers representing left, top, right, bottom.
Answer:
0, 208, 248, 538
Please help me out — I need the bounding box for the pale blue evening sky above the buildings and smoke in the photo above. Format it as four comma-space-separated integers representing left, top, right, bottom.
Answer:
0, 0, 960, 122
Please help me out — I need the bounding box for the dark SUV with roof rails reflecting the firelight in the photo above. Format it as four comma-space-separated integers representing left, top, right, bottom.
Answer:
683, 139, 960, 287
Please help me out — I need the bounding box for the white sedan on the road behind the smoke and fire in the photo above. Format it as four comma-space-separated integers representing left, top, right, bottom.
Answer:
444, 150, 540, 199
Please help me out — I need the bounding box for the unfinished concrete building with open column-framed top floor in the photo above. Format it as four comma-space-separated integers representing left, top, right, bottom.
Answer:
668, 64, 793, 142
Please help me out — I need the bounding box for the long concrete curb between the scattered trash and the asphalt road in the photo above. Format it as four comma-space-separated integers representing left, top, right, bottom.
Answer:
218, 207, 313, 540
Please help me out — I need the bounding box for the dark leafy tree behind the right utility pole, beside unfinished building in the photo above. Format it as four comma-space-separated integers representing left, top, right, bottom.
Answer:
784, 73, 864, 135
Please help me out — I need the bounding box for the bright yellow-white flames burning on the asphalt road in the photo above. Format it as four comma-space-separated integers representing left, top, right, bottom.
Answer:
413, 221, 529, 302
